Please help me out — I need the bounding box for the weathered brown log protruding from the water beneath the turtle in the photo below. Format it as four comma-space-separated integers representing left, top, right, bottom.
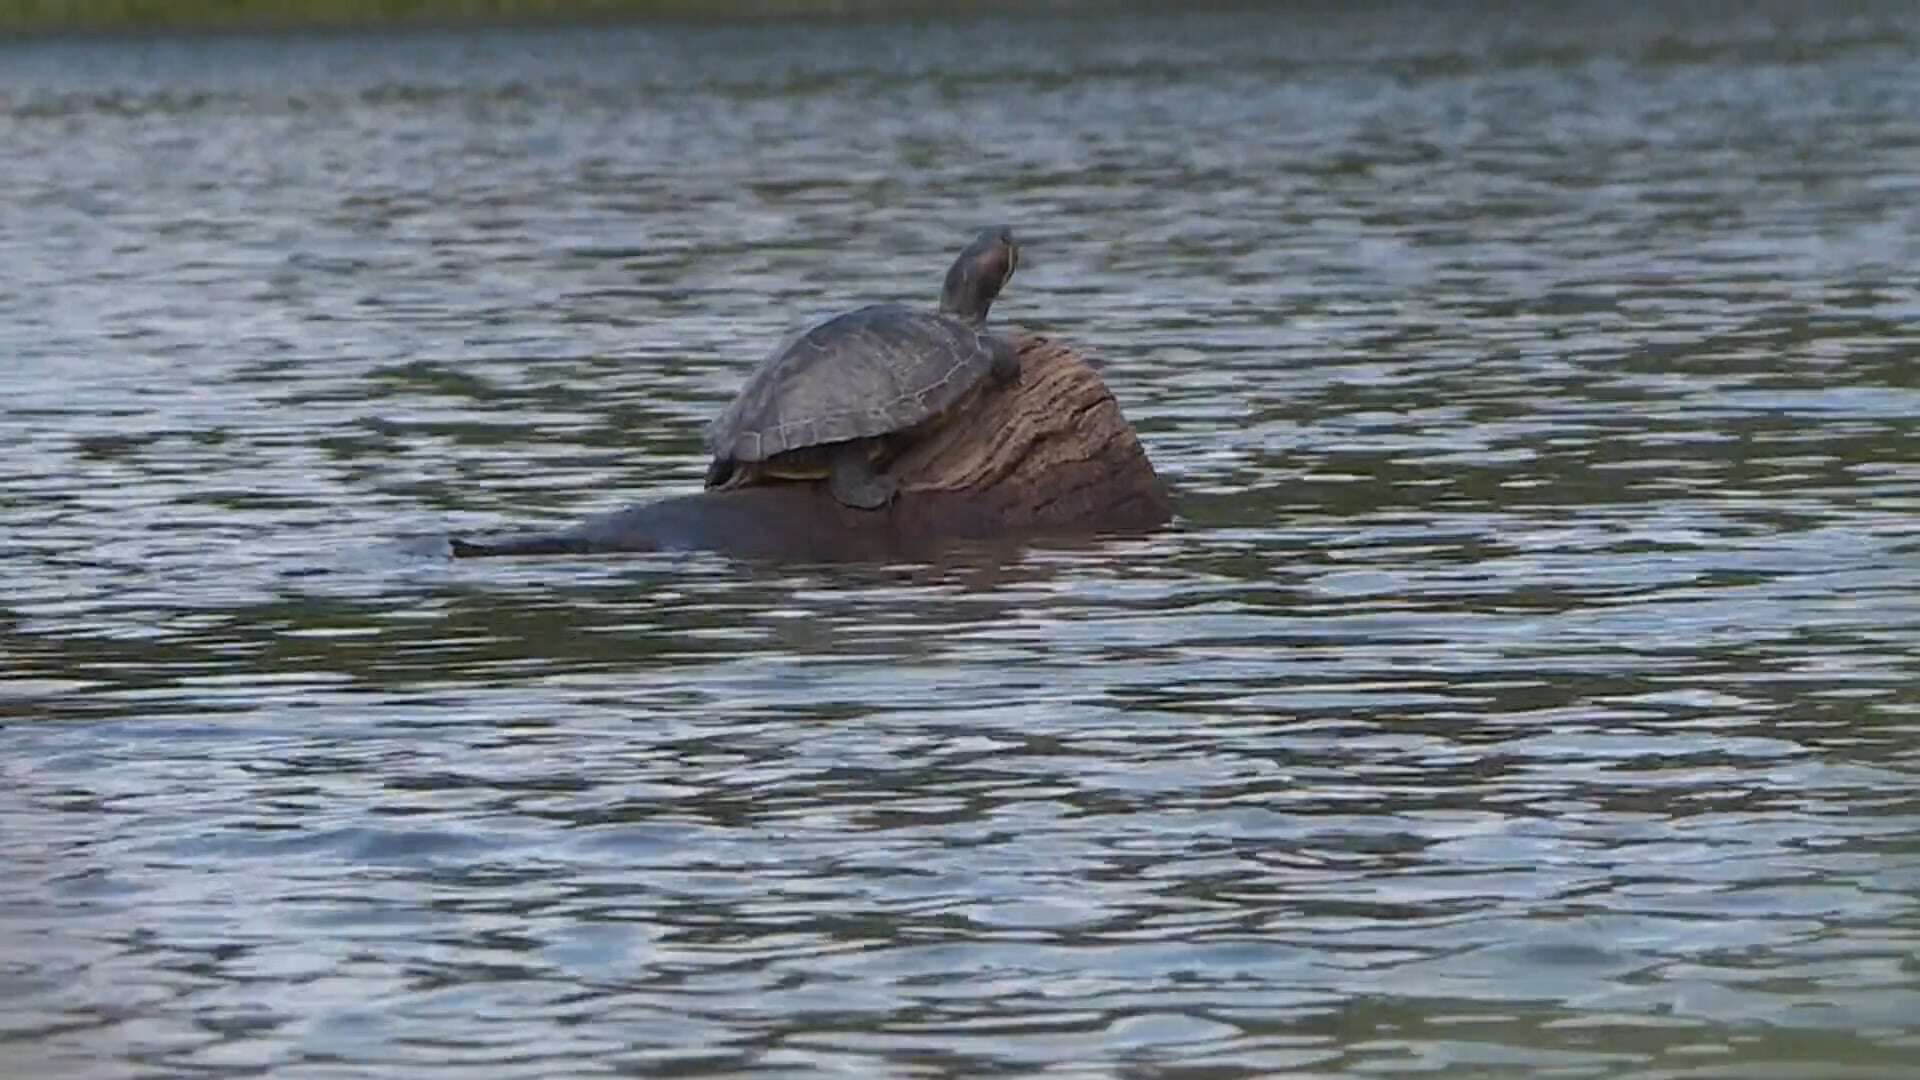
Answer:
451, 332, 1171, 559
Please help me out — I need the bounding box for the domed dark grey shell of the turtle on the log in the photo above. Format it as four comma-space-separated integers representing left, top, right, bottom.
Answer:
707, 304, 993, 461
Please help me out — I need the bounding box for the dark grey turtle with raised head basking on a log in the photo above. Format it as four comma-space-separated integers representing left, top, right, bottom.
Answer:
707, 225, 1020, 509
